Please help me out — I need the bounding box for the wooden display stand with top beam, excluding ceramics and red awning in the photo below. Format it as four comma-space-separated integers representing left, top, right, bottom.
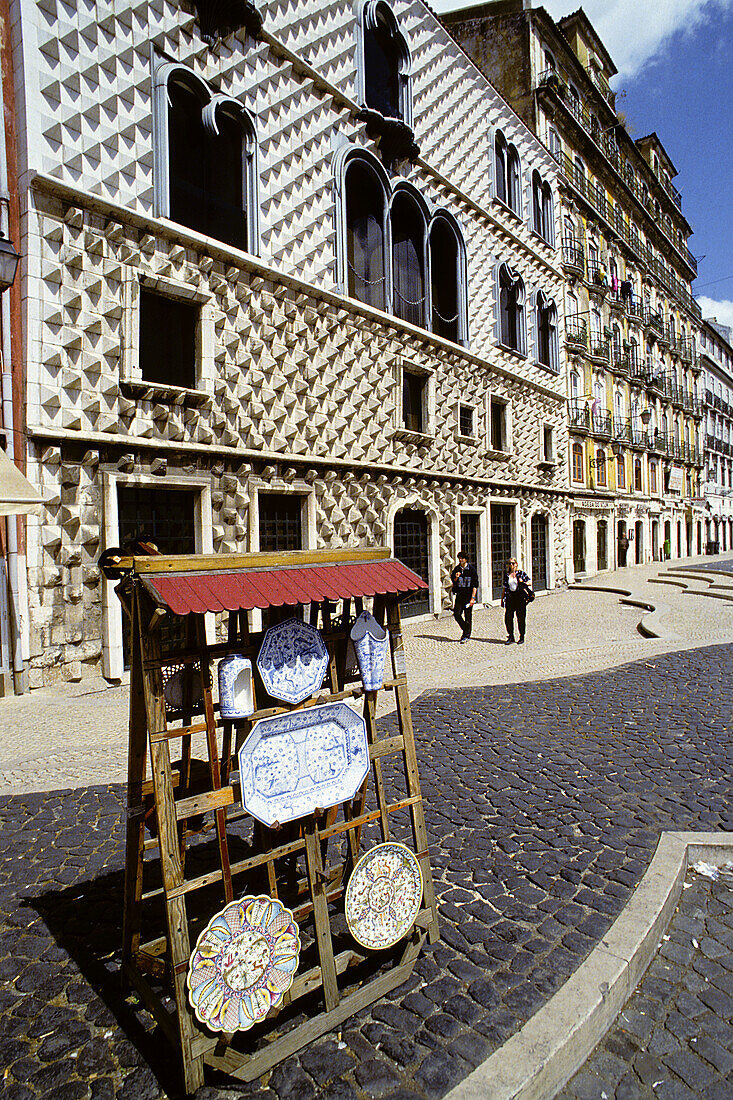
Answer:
108, 550, 438, 1093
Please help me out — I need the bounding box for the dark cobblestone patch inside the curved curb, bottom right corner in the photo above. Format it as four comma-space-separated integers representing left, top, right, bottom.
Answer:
558, 870, 733, 1100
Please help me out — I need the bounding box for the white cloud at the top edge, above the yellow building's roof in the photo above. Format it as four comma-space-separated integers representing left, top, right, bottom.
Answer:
434, 0, 733, 78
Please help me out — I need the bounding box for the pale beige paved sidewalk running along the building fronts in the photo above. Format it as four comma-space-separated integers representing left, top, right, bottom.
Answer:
0, 556, 733, 794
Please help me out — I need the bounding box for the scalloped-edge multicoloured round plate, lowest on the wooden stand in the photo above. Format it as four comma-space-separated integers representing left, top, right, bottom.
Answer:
186, 895, 300, 1032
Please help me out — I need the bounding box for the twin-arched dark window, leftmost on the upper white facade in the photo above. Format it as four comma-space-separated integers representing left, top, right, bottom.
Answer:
162, 65, 256, 252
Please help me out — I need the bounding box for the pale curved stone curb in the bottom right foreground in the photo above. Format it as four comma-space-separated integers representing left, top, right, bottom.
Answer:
444, 832, 733, 1100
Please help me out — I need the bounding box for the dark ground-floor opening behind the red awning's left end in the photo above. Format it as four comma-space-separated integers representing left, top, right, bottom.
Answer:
117, 485, 198, 669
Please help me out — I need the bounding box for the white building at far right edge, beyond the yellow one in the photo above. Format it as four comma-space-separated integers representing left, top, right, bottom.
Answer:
700, 318, 733, 553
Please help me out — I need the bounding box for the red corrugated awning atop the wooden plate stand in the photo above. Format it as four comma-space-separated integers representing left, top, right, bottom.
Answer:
143, 558, 427, 615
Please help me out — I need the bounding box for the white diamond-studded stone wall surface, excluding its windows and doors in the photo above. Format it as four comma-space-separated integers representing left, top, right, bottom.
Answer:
13, 0, 567, 683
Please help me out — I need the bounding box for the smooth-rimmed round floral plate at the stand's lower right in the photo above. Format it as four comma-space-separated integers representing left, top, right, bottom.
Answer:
346, 843, 423, 950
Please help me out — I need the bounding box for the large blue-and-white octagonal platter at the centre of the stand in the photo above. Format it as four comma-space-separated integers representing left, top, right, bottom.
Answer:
239, 703, 369, 825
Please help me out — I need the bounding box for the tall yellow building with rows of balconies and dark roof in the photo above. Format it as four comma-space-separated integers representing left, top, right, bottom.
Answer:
444, 0, 703, 576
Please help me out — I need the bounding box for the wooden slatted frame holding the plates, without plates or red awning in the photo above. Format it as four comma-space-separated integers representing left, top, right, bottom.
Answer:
118, 551, 439, 1093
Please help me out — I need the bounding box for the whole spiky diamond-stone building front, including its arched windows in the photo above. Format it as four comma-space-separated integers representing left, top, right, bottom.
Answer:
5, 0, 568, 686
